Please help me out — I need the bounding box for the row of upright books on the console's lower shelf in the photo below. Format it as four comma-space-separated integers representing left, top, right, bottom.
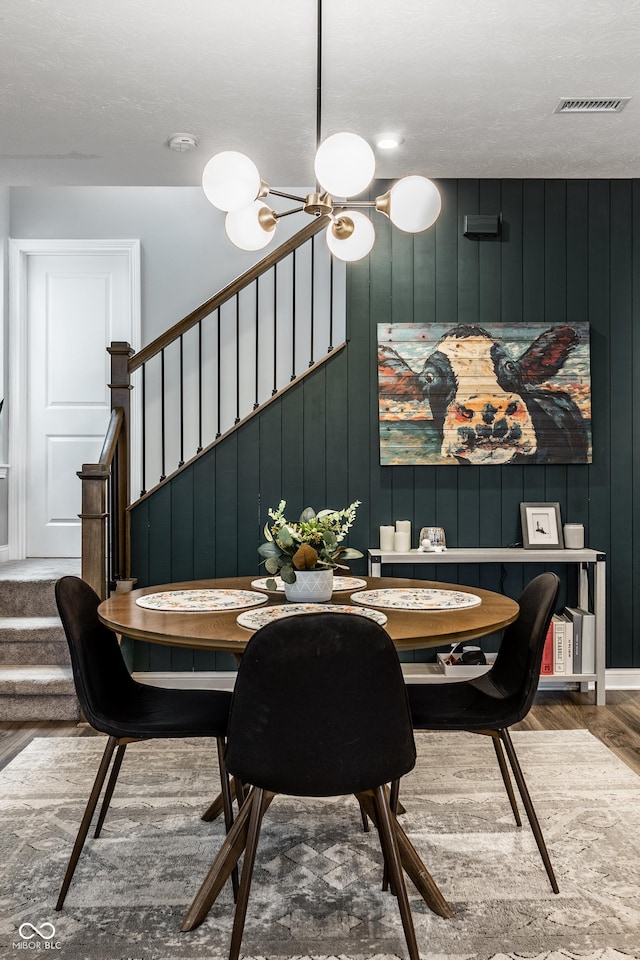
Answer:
540, 607, 596, 677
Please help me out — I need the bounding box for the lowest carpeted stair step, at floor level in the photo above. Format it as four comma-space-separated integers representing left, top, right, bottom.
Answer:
0, 664, 79, 720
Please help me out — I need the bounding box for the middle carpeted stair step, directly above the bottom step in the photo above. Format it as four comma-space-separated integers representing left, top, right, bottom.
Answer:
0, 617, 70, 667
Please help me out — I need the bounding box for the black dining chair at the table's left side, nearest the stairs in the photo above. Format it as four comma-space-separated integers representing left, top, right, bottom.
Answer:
55, 577, 233, 910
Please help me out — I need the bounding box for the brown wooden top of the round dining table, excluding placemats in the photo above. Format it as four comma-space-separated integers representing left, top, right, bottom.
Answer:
98, 577, 519, 655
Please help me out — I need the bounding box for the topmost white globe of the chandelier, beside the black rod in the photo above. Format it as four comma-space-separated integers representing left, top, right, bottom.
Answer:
314, 133, 376, 197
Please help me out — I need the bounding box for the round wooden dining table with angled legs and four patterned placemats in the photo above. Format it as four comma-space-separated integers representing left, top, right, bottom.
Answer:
98, 576, 519, 931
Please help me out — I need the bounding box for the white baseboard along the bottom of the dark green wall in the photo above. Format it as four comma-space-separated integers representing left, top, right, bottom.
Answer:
133, 663, 640, 690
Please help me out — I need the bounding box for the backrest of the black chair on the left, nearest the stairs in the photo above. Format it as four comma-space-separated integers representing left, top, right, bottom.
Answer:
55, 577, 137, 734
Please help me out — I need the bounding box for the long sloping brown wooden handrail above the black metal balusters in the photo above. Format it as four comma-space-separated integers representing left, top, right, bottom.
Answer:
129, 216, 330, 373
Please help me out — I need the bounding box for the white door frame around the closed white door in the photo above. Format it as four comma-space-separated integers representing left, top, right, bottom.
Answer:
7, 239, 141, 560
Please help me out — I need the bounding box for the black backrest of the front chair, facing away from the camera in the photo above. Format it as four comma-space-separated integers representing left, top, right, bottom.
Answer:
225, 613, 416, 796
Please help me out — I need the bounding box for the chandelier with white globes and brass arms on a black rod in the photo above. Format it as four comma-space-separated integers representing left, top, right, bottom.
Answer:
202, 0, 441, 261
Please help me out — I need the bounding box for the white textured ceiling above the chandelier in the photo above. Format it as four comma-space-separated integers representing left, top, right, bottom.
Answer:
0, 0, 640, 186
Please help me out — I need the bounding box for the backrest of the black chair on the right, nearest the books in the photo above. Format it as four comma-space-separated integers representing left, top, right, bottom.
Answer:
480, 573, 560, 723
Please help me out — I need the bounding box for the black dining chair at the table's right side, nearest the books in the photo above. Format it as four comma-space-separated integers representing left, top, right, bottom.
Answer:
404, 573, 560, 893
